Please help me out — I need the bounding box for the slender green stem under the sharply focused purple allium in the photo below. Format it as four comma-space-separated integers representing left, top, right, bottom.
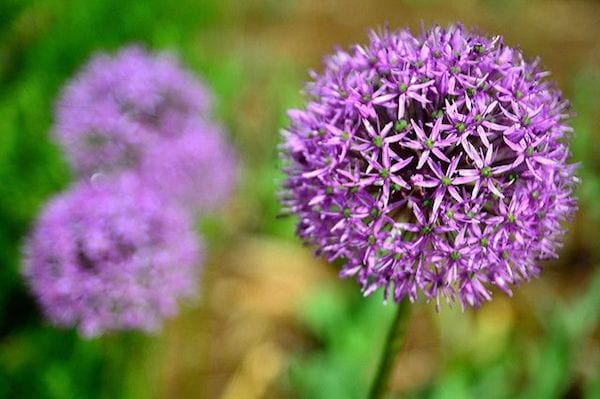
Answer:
369, 298, 410, 399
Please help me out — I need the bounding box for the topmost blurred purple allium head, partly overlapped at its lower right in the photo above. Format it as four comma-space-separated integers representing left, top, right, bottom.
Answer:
53, 46, 211, 177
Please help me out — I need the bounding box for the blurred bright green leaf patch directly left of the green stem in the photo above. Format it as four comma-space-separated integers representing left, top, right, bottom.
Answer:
289, 284, 395, 399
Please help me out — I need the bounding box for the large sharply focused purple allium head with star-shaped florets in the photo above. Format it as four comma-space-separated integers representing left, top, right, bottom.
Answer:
282, 26, 577, 308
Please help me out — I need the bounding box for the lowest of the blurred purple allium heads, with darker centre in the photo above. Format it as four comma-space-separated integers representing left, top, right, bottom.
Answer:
23, 175, 202, 336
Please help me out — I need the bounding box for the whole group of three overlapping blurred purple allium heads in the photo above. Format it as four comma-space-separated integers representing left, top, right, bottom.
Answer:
24, 47, 236, 336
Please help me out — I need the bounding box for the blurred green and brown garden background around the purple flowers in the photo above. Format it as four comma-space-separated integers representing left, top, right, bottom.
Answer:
0, 0, 600, 399
